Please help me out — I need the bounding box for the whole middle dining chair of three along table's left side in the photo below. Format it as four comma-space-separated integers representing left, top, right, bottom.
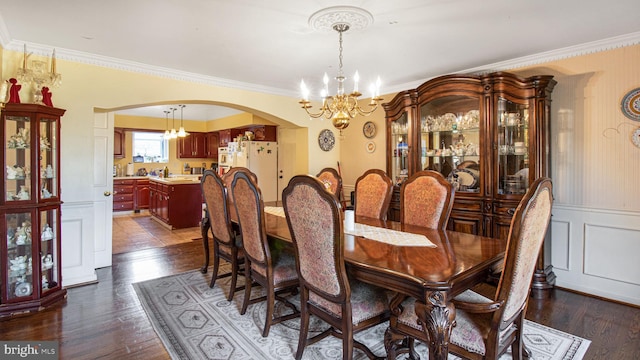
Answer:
231, 171, 300, 337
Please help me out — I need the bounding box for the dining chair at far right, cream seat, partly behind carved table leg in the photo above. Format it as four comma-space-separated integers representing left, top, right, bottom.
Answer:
387, 177, 553, 360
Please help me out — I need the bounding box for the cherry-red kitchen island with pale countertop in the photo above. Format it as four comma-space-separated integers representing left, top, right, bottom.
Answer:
149, 177, 203, 229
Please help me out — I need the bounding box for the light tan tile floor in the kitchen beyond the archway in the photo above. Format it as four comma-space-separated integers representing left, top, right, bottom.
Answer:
112, 211, 202, 254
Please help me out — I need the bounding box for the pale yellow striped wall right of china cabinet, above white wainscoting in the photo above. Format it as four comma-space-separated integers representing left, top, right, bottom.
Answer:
513, 45, 640, 211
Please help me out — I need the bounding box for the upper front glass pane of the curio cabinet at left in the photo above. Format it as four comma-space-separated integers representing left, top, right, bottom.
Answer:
4, 116, 33, 203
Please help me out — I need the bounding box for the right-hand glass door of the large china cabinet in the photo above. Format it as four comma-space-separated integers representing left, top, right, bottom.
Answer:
496, 97, 529, 194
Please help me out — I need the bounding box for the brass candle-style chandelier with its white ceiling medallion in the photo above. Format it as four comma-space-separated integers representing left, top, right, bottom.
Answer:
299, 6, 382, 134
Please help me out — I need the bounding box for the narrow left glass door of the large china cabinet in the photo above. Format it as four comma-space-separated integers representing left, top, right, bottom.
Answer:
389, 113, 409, 185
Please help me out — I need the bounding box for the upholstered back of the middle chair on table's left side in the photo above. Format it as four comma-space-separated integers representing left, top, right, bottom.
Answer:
231, 171, 271, 270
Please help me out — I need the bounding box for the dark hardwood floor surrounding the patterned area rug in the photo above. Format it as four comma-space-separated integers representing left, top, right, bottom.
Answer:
0, 241, 640, 360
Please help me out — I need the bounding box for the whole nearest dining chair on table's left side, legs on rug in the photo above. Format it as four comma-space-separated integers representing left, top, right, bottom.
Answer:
282, 175, 389, 360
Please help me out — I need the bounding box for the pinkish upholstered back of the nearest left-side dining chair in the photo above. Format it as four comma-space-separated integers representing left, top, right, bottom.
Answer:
282, 175, 349, 314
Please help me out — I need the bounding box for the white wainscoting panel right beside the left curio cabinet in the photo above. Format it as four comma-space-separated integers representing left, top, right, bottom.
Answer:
61, 202, 98, 287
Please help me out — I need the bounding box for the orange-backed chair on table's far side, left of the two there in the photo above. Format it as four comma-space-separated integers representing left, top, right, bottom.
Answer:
354, 169, 393, 220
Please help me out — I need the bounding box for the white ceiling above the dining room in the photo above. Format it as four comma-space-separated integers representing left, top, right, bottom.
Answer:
0, 0, 640, 119
